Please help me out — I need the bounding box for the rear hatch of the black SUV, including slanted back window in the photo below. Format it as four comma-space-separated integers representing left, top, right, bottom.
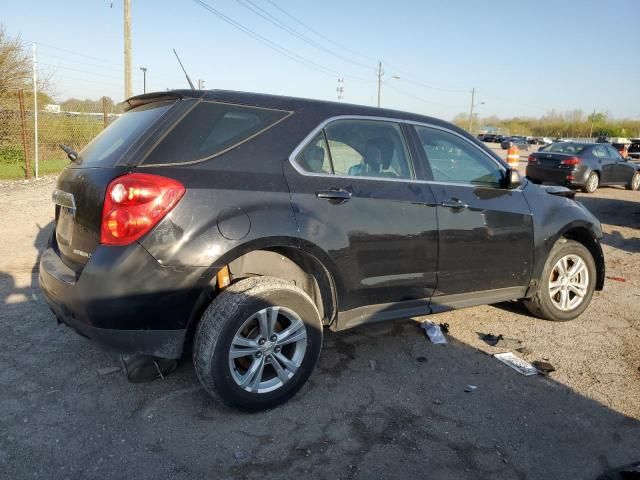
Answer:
53, 98, 176, 272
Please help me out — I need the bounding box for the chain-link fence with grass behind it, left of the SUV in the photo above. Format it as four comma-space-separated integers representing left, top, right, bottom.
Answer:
0, 91, 122, 179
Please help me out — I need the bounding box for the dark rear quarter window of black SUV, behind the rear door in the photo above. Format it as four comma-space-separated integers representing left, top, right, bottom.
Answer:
144, 102, 289, 165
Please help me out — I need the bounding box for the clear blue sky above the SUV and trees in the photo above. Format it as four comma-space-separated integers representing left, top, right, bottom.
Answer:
0, 0, 640, 119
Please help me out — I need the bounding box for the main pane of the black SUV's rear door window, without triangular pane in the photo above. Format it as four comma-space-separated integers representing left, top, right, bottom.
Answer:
325, 120, 414, 179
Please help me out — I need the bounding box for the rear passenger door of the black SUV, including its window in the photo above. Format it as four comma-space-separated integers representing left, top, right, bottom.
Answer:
285, 118, 438, 313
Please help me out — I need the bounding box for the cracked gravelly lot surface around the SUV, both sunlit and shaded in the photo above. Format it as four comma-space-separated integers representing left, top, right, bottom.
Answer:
0, 171, 640, 479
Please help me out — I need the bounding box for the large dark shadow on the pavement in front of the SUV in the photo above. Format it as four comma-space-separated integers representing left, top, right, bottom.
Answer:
0, 266, 640, 479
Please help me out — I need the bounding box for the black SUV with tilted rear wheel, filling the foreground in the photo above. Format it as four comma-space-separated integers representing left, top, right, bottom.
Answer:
40, 91, 604, 409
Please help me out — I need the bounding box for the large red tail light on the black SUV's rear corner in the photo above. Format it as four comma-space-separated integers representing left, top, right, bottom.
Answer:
100, 173, 185, 245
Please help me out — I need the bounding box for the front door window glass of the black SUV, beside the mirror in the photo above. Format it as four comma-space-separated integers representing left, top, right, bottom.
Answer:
416, 127, 503, 186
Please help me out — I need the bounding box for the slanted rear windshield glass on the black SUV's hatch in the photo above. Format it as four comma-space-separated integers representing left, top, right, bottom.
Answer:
79, 101, 174, 167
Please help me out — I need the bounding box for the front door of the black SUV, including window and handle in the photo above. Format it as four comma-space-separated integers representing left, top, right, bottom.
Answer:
414, 126, 533, 311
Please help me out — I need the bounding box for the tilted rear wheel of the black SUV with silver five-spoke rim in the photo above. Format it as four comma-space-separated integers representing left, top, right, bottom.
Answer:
193, 277, 322, 410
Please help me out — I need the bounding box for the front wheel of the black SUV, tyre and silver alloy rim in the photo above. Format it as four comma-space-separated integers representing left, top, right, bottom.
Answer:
524, 238, 596, 322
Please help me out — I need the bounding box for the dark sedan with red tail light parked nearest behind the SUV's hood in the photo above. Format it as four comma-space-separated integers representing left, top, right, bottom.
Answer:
527, 142, 640, 193
